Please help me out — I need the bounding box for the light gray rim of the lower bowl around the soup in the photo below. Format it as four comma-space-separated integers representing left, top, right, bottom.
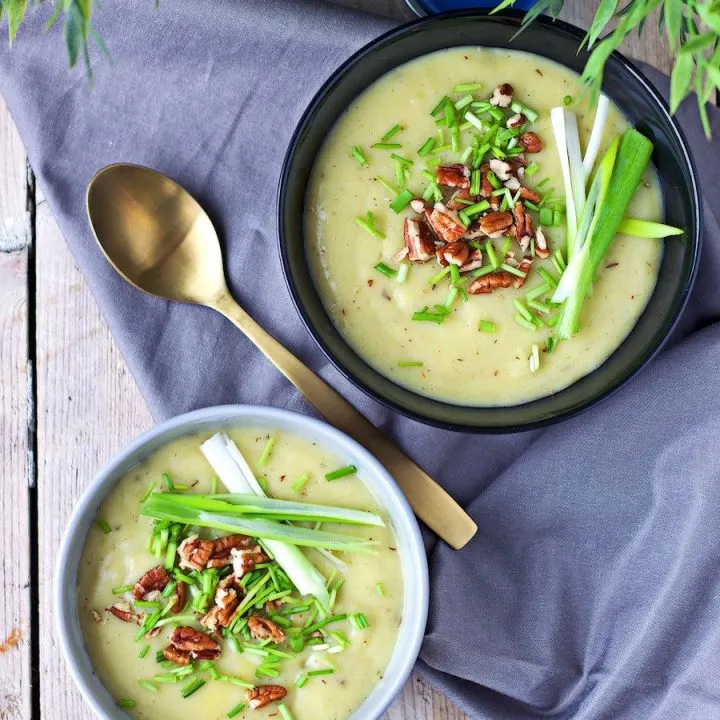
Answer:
52, 404, 430, 720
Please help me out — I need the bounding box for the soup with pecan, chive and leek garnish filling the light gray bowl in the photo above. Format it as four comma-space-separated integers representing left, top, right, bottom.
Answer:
83, 428, 403, 720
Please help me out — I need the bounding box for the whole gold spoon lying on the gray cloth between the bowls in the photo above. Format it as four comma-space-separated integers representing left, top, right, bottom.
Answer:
87, 164, 477, 549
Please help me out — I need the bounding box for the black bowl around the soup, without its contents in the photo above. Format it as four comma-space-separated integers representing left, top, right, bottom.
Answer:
278, 11, 702, 432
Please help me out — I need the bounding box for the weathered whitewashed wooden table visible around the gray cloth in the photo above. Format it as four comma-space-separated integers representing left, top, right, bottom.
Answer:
0, 0, 671, 720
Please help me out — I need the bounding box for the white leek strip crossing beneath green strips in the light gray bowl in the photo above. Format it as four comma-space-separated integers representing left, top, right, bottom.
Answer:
200, 433, 330, 607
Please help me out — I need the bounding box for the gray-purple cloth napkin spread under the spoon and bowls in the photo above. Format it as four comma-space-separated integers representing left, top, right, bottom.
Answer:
0, 0, 720, 720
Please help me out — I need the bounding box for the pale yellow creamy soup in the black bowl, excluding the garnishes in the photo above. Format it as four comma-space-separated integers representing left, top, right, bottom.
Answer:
305, 47, 662, 406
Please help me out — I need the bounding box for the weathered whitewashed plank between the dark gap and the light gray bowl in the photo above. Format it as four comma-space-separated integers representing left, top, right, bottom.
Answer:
36, 188, 151, 720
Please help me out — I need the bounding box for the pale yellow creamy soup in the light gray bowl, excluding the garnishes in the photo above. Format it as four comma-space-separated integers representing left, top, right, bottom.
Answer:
78, 428, 403, 720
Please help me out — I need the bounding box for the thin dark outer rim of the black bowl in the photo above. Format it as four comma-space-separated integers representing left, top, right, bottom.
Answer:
275, 9, 704, 435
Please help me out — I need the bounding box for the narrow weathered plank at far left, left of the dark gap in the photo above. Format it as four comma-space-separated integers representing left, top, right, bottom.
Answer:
0, 100, 31, 720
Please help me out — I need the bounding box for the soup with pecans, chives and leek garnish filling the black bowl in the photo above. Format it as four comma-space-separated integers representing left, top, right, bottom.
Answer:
305, 47, 664, 406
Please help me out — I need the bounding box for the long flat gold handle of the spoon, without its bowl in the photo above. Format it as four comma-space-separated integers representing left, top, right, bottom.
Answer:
213, 292, 477, 550
